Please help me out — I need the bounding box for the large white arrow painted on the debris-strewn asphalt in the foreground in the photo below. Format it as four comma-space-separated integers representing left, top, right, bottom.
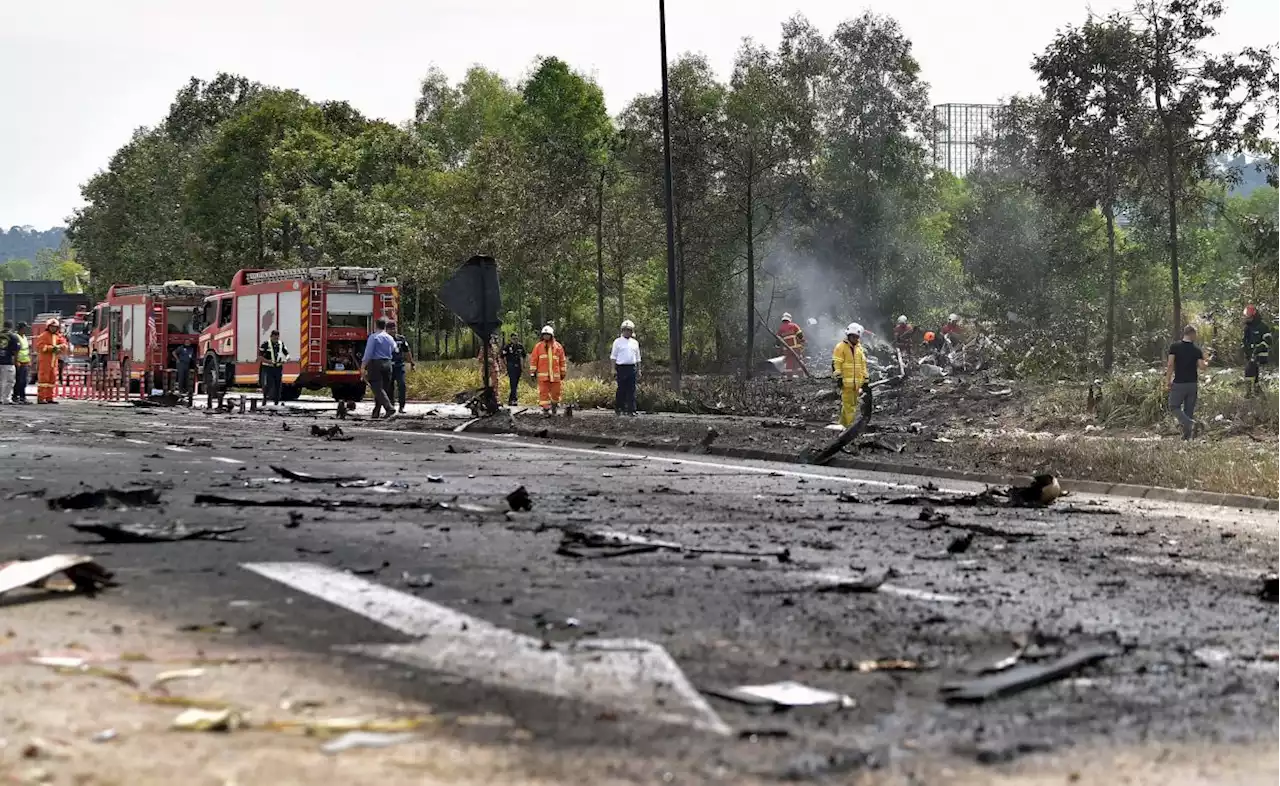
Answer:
243, 562, 730, 735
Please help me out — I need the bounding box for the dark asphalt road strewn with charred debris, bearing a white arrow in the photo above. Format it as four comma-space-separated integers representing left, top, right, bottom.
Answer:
0, 403, 1280, 782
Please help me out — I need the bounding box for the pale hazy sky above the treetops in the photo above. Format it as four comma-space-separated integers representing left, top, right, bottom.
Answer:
0, 0, 1280, 228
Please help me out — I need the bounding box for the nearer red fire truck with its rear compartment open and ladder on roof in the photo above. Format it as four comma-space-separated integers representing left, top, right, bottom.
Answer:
198, 268, 399, 401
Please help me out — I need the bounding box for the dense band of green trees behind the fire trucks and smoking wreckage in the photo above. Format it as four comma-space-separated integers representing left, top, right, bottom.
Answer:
70, 0, 1280, 373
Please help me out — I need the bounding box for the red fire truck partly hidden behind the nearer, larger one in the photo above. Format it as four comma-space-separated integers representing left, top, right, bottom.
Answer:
88, 280, 218, 380
